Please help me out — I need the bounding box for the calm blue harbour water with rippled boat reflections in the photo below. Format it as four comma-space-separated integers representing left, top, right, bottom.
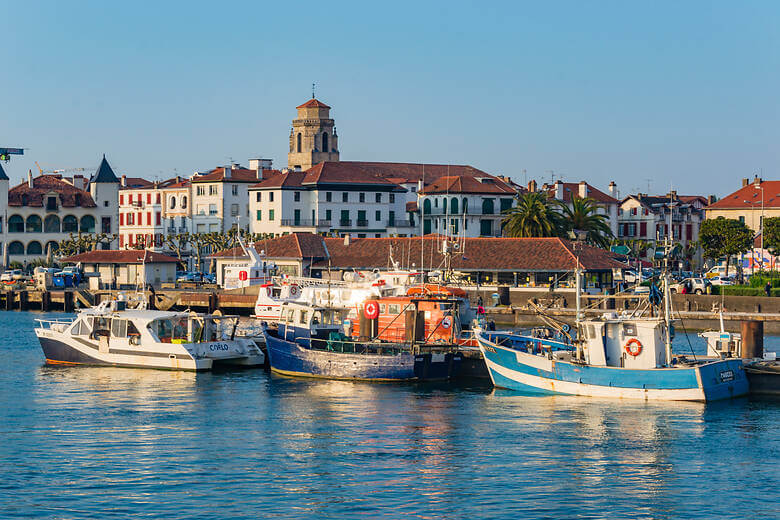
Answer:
0, 312, 780, 519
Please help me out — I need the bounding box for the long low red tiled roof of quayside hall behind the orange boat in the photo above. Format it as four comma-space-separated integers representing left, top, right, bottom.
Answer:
315, 235, 624, 272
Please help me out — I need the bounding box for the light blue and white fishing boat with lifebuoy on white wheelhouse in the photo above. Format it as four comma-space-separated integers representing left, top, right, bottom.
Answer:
476, 260, 748, 401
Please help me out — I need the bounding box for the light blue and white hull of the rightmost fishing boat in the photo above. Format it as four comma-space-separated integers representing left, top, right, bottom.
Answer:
479, 336, 748, 401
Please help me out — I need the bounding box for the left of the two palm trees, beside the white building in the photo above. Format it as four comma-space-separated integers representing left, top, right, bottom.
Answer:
503, 191, 565, 237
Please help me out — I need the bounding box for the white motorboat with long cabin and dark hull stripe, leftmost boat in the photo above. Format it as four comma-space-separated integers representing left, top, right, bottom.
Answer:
35, 300, 265, 370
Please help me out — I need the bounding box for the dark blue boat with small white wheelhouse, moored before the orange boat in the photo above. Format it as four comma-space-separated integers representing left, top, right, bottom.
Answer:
263, 302, 461, 381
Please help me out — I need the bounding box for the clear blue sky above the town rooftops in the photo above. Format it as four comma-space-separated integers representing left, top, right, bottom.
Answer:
0, 0, 780, 195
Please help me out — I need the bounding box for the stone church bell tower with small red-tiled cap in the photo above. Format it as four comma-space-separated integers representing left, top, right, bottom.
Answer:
287, 97, 339, 170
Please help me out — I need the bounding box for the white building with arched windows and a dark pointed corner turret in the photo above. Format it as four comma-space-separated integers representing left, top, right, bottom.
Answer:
0, 156, 119, 263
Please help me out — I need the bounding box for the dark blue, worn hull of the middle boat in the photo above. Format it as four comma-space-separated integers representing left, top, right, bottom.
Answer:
265, 333, 461, 382
